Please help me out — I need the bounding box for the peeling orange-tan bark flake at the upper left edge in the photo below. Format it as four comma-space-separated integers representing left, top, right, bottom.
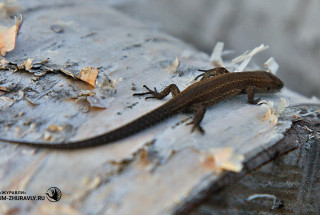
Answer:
0, 15, 23, 56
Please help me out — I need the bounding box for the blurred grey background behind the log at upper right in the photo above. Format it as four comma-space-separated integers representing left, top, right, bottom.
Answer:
108, 0, 320, 98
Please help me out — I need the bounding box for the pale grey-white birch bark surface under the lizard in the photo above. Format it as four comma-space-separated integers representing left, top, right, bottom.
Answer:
0, 1, 318, 214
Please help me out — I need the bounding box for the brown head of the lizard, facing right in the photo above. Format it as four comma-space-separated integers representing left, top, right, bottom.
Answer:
256, 72, 284, 93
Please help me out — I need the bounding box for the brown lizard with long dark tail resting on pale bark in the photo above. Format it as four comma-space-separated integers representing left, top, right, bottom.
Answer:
0, 67, 284, 150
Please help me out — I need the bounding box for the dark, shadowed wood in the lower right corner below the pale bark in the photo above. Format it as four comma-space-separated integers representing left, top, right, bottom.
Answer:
191, 105, 320, 215
